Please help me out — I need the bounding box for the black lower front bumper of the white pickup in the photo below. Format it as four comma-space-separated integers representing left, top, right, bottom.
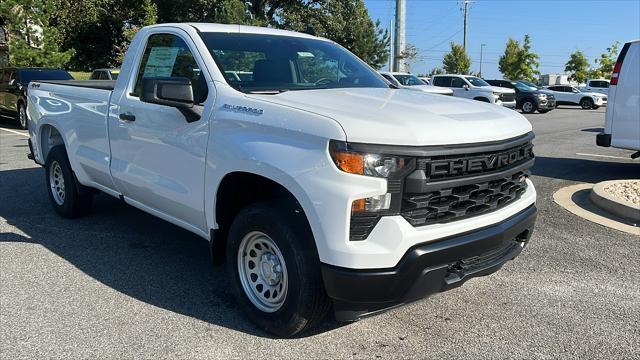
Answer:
322, 205, 537, 321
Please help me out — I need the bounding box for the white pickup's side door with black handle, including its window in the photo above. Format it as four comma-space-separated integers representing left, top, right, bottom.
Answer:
108, 29, 214, 231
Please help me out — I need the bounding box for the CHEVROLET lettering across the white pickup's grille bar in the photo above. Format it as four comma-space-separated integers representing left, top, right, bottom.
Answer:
428, 144, 533, 176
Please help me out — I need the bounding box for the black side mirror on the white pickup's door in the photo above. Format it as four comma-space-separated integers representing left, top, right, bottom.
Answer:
140, 77, 202, 122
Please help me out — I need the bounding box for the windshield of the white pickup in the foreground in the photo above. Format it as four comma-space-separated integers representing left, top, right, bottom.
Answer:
200, 33, 388, 92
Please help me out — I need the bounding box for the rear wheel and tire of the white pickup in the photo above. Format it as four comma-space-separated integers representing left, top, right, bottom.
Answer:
45, 146, 93, 218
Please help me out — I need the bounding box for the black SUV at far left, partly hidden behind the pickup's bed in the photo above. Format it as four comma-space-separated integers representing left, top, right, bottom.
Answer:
0, 68, 73, 129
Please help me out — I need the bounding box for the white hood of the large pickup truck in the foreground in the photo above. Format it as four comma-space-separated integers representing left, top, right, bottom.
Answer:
248, 88, 531, 146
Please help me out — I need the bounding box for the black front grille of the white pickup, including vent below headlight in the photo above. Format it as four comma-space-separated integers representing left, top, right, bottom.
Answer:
350, 133, 534, 241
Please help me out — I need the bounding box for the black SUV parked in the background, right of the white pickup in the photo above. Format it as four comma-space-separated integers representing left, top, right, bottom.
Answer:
485, 80, 556, 114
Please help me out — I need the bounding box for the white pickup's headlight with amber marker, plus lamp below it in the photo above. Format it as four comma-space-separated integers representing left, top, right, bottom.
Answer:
329, 140, 415, 215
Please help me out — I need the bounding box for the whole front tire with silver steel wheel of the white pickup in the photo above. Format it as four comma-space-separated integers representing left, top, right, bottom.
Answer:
227, 200, 331, 337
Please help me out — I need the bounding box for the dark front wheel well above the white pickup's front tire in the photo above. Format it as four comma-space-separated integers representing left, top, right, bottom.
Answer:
211, 172, 306, 264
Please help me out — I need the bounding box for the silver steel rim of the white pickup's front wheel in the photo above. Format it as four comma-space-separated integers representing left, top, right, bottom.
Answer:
238, 231, 288, 313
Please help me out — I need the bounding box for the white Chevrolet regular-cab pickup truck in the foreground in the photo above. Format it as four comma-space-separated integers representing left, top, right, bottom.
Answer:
28, 24, 536, 336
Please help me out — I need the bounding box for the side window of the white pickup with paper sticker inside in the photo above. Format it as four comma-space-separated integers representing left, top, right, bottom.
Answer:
132, 34, 208, 104
